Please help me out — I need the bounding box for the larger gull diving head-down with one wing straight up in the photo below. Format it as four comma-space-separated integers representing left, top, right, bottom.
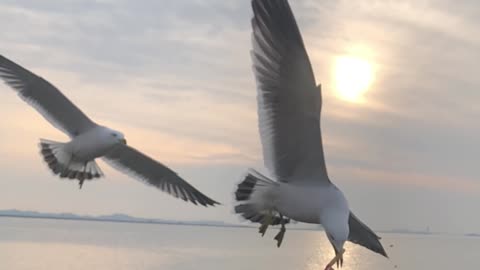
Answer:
235, 0, 388, 270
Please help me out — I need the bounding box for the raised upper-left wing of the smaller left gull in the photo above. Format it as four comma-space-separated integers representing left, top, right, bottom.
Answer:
0, 55, 96, 138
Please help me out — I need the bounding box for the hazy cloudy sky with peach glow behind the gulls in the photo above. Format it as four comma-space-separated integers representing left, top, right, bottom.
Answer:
0, 0, 480, 232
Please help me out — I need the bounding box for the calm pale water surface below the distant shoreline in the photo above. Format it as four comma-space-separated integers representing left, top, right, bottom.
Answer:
0, 217, 480, 270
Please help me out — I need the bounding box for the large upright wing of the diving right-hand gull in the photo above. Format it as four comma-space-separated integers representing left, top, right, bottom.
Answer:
251, 0, 330, 182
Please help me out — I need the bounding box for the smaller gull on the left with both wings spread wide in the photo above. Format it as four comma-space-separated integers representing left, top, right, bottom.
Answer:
0, 55, 218, 206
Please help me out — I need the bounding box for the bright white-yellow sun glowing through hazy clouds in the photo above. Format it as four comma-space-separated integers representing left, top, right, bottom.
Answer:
335, 56, 373, 102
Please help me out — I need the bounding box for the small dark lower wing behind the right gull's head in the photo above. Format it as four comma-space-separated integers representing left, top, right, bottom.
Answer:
348, 212, 388, 258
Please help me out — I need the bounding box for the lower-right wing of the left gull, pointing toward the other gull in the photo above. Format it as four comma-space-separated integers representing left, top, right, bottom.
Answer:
104, 144, 218, 206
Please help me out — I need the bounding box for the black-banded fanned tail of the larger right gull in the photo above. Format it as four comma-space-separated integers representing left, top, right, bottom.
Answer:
235, 170, 289, 225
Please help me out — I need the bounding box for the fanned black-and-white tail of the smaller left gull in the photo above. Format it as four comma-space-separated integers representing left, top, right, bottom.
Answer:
39, 139, 103, 187
